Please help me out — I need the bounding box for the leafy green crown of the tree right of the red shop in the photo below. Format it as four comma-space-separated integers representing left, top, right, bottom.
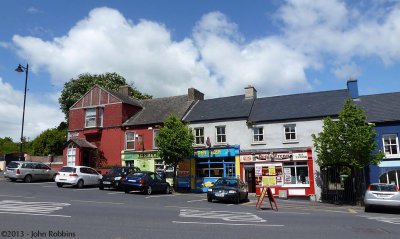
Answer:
312, 100, 383, 169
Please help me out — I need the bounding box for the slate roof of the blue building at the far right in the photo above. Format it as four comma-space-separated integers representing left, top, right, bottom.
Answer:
356, 92, 400, 123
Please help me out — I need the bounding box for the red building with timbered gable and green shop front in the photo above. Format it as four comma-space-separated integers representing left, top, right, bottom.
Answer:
63, 85, 204, 170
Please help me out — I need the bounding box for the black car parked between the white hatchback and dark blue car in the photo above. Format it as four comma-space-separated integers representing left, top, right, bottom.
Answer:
99, 167, 140, 190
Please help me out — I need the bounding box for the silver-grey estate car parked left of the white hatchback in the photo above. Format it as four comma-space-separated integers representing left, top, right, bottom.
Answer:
4, 161, 57, 183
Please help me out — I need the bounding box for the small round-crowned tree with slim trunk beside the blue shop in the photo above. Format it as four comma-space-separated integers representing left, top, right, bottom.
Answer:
156, 115, 194, 189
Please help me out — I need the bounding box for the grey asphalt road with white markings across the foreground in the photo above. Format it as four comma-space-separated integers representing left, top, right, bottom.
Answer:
0, 175, 400, 239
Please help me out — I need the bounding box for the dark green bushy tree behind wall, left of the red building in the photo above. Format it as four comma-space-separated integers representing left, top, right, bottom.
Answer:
32, 128, 67, 156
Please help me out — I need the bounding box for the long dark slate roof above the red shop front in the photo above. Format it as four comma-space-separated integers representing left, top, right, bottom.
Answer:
249, 90, 350, 122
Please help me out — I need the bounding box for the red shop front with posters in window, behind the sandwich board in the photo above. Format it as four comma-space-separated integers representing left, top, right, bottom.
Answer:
240, 148, 315, 197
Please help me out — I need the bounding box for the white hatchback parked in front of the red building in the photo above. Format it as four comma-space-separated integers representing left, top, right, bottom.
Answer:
55, 166, 102, 188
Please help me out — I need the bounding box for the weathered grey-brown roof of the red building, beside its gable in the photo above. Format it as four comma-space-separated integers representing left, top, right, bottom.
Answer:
123, 95, 194, 126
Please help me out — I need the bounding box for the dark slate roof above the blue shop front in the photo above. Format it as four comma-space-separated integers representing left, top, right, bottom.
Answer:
184, 95, 254, 122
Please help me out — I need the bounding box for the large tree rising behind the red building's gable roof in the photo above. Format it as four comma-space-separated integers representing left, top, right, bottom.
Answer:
58, 73, 151, 120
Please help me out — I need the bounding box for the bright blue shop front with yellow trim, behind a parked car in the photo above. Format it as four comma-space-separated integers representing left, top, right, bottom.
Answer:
192, 145, 240, 192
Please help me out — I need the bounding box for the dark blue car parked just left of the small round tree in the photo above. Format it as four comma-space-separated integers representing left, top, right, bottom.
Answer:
122, 171, 171, 195
